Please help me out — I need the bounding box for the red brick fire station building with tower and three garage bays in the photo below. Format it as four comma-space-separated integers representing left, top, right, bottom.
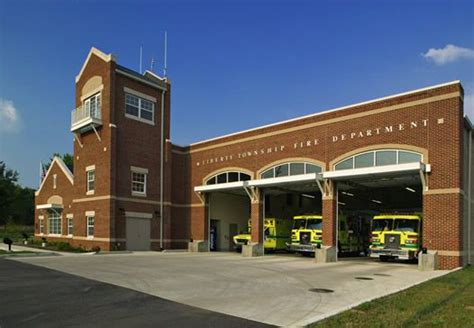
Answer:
35, 48, 474, 269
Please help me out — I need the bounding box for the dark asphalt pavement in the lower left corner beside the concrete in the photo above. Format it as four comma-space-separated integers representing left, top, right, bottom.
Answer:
0, 258, 267, 328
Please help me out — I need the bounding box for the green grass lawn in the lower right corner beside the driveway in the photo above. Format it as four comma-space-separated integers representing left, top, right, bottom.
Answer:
309, 267, 474, 328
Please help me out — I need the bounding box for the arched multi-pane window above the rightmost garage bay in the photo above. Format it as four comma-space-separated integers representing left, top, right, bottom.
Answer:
334, 149, 423, 171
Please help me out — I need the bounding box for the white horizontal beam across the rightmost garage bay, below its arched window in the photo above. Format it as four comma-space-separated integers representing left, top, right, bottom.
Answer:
322, 162, 431, 180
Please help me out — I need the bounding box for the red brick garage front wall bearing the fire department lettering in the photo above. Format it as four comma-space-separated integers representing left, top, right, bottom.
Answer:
183, 84, 463, 263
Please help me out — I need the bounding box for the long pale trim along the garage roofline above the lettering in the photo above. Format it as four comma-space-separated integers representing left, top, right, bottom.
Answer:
190, 80, 461, 148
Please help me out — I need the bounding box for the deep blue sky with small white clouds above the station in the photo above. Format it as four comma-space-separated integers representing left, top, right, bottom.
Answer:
0, 0, 474, 188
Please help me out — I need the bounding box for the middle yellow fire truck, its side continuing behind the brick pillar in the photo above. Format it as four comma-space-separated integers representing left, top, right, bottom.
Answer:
287, 214, 365, 254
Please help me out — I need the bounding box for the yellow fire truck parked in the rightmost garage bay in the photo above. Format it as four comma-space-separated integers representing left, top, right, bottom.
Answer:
369, 214, 422, 261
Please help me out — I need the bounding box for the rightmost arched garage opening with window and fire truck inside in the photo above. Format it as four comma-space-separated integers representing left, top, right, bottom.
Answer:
324, 148, 429, 260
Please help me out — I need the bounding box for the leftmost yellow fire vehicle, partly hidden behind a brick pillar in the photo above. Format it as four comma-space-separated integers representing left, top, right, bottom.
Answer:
234, 218, 293, 252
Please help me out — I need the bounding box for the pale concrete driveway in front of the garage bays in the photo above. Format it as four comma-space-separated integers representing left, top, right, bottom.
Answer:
10, 252, 449, 326
